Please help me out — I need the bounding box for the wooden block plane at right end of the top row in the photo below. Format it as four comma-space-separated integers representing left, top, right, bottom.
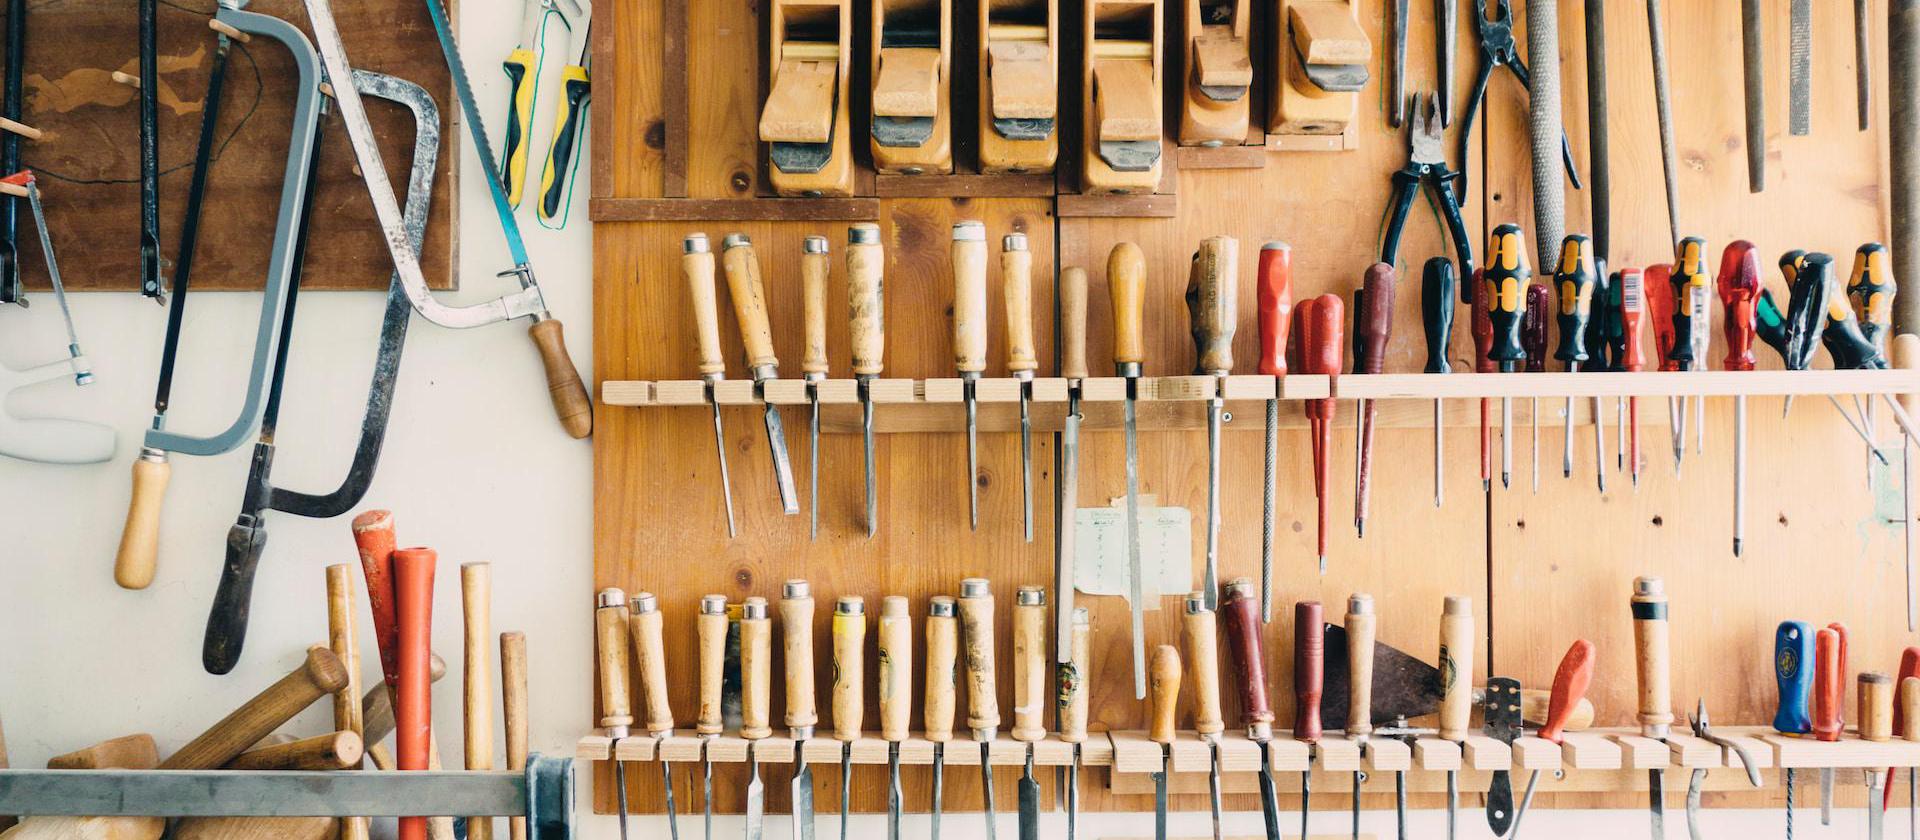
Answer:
1267, 0, 1373, 134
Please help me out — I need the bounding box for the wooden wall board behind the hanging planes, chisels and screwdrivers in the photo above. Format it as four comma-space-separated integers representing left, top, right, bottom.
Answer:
580, 0, 1920, 811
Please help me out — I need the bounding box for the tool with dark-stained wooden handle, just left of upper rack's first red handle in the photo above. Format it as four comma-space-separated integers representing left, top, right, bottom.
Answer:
1187, 236, 1240, 610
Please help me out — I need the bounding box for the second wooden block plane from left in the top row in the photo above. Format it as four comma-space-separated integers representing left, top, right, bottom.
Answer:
870, 0, 954, 175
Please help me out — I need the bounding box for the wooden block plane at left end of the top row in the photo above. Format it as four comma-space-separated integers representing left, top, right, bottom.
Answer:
760, 0, 852, 198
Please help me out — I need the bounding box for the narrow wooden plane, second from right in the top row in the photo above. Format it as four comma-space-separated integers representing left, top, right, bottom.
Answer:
1181, 0, 1254, 146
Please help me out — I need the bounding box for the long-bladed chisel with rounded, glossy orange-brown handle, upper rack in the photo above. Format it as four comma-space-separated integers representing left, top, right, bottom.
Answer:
1106, 242, 1146, 700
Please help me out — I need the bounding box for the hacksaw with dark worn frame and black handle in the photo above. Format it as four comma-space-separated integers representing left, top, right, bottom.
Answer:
200, 69, 440, 673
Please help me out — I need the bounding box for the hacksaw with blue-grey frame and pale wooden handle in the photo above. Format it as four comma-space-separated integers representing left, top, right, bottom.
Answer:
113, 0, 321, 589
